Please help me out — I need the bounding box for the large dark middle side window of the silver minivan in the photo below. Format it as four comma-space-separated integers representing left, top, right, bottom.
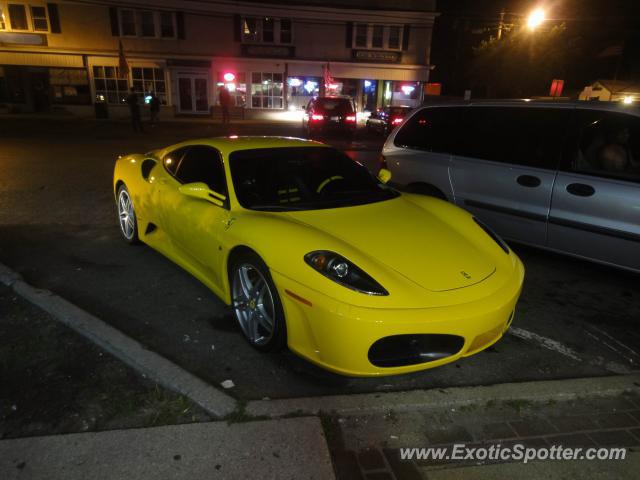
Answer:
457, 106, 571, 170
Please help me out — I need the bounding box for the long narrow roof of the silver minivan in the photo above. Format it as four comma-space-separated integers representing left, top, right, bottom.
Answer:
422, 98, 640, 115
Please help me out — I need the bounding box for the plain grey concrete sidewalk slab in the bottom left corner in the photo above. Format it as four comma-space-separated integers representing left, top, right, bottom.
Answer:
0, 417, 334, 480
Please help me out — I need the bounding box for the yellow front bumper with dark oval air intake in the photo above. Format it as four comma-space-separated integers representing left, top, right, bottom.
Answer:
271, 260, 524, 376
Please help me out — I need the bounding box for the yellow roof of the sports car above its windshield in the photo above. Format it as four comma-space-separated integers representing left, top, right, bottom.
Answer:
161, 135, 330, 156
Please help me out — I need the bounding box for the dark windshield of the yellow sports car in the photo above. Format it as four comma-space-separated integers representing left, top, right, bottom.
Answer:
229, 147, 399, 211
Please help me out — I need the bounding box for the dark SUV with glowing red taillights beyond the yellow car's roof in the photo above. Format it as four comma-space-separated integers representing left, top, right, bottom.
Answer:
302, 97, 357, 137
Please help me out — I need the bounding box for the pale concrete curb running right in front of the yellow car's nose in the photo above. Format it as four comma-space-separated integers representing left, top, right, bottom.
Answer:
246, 373, 640, 418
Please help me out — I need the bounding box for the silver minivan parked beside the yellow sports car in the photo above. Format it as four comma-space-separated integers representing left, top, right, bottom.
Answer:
381, 101, 640, 272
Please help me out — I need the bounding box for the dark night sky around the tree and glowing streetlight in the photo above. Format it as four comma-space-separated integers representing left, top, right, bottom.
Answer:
431, 0, 640, 95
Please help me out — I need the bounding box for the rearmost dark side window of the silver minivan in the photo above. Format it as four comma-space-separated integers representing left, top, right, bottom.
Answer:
396, 107, 461, 153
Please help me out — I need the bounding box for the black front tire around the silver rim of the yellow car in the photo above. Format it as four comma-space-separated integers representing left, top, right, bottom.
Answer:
229, 252, 287, 352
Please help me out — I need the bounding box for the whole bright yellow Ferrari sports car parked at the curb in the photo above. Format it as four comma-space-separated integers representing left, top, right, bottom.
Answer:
113, 137, 524, 376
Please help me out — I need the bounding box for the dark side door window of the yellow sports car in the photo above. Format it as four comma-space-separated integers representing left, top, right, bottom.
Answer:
176, 145, 227, 195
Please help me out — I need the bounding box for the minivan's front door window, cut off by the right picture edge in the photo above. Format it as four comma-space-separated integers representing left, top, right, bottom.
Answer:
570, 110, 640, 182
